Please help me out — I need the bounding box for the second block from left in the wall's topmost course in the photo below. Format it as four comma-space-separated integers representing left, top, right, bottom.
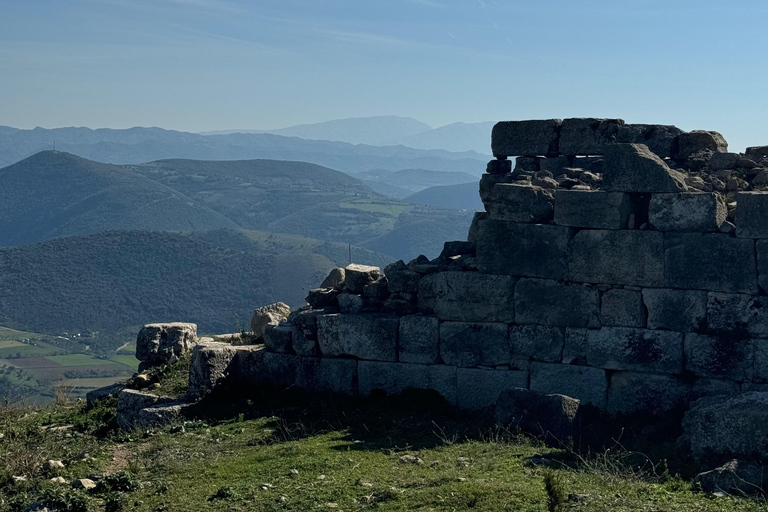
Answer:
560, 118, 624, 156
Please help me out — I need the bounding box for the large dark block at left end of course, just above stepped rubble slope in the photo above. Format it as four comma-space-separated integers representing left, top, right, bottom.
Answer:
475, 219, 572, 279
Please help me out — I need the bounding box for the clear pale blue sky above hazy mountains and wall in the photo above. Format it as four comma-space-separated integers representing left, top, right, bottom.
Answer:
0, 0, 768, 151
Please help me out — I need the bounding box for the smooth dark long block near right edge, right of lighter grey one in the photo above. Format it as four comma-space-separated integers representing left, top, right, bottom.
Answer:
663, 233, 757, 294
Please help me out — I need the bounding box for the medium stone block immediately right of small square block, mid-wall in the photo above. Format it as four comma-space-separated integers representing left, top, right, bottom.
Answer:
643, 288, 707, 332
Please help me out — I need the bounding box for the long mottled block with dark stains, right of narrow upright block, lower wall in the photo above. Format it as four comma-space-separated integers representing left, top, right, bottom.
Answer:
587, 327, 683, 374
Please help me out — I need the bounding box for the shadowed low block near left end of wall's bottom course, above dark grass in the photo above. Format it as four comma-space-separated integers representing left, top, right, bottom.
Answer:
298, 357, 358, 395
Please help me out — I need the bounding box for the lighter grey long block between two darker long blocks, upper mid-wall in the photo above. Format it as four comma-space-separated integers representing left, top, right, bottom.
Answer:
568, 230, 664, 286
